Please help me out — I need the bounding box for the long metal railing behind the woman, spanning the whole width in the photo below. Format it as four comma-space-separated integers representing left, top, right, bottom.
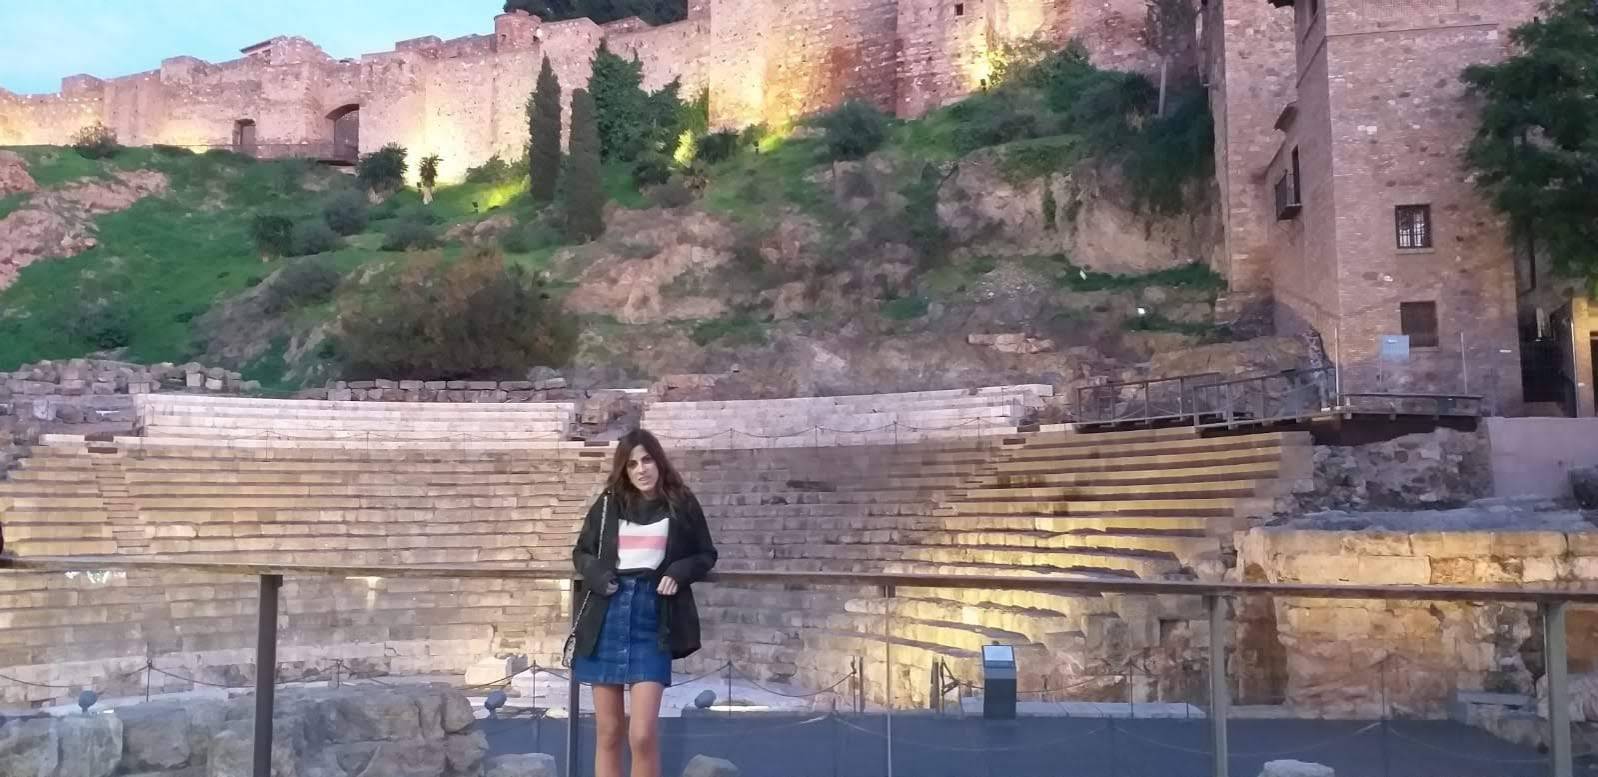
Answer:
0, 556, 1598, 777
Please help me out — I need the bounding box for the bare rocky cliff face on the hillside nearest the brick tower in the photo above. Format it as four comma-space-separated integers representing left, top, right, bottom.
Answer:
938, 149, 1219, 273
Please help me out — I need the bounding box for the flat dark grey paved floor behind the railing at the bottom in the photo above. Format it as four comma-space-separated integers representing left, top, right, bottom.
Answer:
483, 713, 1578, 777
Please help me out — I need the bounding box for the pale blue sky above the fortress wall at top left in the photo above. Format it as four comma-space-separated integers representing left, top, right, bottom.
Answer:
0, 0, 503, 94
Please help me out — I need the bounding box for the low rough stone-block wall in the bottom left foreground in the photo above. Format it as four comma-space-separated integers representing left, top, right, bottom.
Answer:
0, 686, 485, 777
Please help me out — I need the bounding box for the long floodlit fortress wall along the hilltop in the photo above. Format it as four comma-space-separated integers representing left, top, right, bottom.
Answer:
0, 0, 1152, 181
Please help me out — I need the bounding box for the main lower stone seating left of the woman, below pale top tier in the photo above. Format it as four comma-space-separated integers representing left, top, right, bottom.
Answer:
0, 436, 610, 705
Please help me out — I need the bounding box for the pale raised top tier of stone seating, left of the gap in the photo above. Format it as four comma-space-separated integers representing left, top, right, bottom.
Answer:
136, 393, 575, 448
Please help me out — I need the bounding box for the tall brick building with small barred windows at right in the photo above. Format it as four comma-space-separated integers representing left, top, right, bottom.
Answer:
1203, 0, 1566, 414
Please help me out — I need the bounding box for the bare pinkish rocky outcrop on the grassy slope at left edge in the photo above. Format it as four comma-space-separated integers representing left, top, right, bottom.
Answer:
0, 169, 166, 289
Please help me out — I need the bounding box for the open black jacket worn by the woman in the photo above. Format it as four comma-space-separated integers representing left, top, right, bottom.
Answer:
572, 494, 716, 659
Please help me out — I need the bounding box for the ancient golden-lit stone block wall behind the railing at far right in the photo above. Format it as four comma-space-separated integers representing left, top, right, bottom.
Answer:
1237, 508, 1598, 718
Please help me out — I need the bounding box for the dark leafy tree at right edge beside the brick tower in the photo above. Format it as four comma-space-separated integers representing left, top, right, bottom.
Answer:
1464, 0, 1598, 284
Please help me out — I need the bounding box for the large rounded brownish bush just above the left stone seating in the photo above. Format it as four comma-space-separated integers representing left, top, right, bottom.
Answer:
334, 248, 575, 381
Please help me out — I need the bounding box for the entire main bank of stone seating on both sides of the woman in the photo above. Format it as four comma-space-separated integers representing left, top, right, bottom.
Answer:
0, 388, 1309, 703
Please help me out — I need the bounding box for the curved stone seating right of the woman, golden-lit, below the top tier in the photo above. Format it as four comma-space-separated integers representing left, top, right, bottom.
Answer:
682, 428, 1309, 703
